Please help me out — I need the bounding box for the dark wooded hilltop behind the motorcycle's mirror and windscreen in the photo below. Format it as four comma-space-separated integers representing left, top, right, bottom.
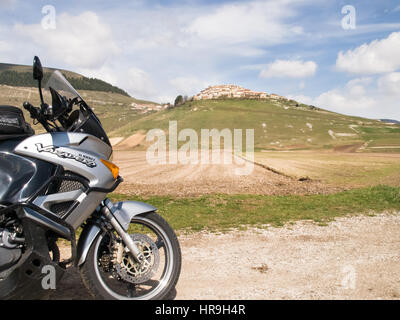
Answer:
0, 63, 129, 97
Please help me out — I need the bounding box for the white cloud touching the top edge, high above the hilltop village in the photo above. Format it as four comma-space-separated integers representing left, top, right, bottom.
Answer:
184, 0, 303, 44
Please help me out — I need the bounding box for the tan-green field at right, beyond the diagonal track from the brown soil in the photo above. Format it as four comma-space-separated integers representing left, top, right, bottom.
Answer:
255, 150, 400, 189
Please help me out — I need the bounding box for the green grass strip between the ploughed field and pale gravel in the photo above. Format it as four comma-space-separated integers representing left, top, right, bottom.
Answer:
111, 186, 400, 232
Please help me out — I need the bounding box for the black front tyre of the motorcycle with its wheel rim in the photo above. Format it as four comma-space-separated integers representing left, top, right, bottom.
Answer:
80, 212, 182, 300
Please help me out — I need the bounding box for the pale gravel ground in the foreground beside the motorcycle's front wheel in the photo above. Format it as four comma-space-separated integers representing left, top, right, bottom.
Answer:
52, 213, 400, 299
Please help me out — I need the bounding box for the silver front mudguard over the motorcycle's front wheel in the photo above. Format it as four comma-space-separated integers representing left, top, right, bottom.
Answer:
77, 201, 157, 266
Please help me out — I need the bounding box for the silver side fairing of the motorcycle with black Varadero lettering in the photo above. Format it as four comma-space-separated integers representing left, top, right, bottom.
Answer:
14, 132, 115, 229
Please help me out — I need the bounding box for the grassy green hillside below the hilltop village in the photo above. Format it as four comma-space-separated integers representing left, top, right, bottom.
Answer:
113, 98, 400, 152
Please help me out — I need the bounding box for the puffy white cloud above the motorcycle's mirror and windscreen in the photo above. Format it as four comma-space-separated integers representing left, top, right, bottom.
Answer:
14, 11, 120, 69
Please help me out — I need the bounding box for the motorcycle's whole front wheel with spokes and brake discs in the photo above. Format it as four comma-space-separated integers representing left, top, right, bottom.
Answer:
80, 212, 181, 300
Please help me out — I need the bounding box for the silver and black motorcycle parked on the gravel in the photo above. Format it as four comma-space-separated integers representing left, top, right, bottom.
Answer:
0, 57, 181, 300
